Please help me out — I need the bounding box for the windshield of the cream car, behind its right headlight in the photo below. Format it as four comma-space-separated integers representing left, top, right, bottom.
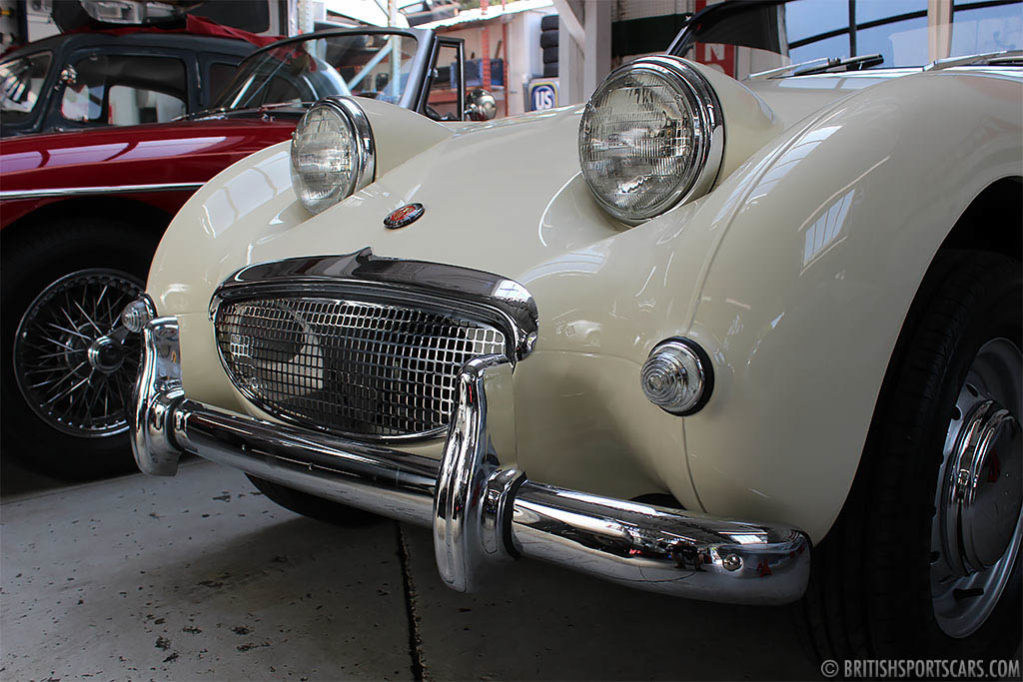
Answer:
672, 0, 1023, 78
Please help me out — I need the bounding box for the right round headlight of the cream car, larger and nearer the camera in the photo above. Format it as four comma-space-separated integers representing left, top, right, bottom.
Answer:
579, 56, 724, 223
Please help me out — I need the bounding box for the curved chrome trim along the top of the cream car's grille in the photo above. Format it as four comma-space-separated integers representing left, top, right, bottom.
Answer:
210, 246, 539, 362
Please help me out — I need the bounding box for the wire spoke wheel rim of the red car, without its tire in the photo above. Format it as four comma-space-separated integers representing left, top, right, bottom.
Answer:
13, 269, 142, 438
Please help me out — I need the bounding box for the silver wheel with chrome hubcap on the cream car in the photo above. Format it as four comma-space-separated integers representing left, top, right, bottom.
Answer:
931, 338, 1023, 637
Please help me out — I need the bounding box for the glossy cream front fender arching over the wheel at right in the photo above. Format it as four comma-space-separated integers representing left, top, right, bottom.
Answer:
684, 72, 1023, 542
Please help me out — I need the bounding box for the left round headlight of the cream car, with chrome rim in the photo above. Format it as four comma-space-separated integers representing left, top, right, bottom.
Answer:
292, 97, 375, 213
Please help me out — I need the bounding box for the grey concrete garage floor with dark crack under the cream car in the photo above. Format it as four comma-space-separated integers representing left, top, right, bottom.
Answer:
0, 461, 819, 680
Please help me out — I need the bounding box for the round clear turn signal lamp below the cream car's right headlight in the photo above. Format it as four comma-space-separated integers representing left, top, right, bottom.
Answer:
640, 338, 714, 416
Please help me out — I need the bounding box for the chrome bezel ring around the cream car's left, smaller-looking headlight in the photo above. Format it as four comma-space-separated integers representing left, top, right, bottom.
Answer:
290, 96, 376, 214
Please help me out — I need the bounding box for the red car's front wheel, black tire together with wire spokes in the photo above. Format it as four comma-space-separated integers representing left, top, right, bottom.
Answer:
0, 218, 159, 480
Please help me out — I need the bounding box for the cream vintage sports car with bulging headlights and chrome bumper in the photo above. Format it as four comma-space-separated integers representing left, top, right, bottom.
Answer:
116, 2, 1023, 658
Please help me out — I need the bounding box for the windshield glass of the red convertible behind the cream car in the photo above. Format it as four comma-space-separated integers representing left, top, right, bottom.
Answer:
214, 33, 417, 109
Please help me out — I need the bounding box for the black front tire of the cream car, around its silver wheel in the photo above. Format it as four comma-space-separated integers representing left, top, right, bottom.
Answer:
797, 252, 1023, 662
